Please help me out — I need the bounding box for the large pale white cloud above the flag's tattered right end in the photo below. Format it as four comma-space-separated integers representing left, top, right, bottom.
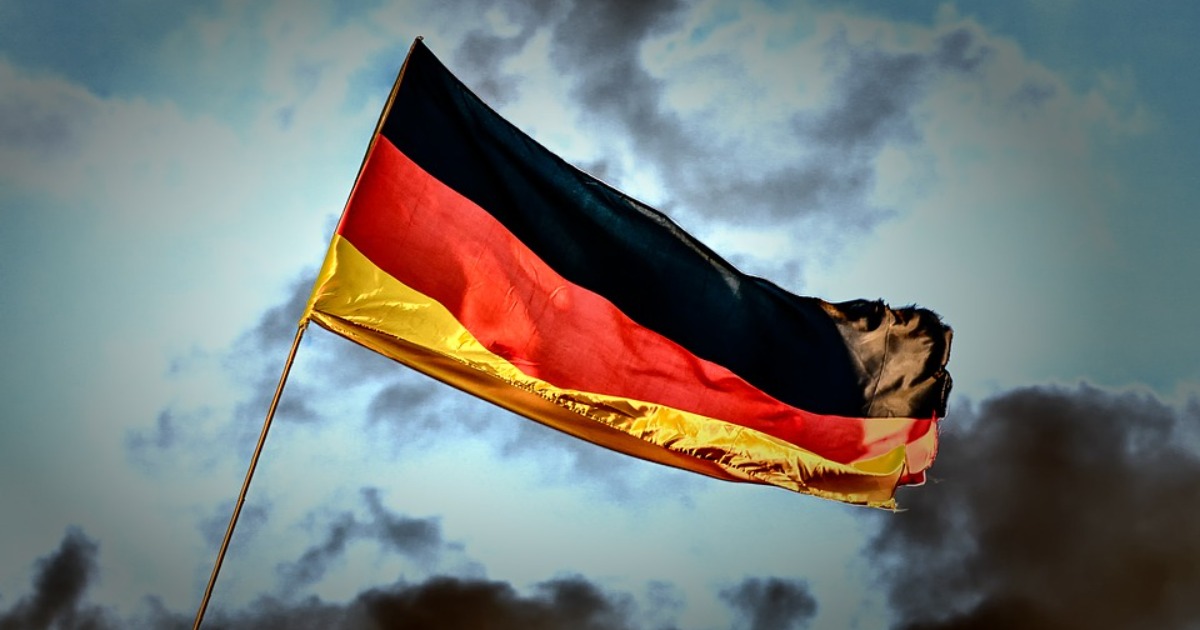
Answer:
814, 15, 1145, 395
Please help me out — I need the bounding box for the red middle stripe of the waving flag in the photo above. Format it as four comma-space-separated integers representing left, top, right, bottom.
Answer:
338, 137, 934, 463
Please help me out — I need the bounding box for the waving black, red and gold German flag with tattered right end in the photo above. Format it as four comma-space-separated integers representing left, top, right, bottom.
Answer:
304, 38, 950, 508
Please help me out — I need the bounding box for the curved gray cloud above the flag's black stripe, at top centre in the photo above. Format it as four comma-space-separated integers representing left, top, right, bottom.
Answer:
540, 11, 990, 228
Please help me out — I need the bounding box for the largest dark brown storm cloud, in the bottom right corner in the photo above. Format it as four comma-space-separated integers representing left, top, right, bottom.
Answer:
874, 386, 1200, 629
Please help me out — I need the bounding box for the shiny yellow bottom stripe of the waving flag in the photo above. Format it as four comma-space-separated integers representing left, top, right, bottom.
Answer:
305, 235, 907, 508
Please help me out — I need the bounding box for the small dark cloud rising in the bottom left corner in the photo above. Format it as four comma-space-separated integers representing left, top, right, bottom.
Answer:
0, 528, 115, 630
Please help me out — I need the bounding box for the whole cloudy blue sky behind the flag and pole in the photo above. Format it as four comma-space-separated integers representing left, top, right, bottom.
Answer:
0, 0, 1200, 630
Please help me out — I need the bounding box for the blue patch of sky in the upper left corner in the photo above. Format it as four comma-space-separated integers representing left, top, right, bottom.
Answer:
0, 0, 364, 126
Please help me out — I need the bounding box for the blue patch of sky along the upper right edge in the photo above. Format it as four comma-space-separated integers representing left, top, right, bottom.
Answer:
806, 0, 1200, 391
